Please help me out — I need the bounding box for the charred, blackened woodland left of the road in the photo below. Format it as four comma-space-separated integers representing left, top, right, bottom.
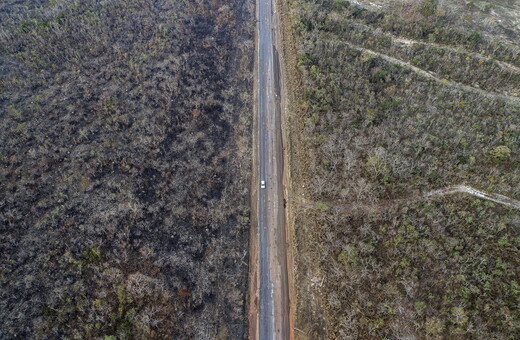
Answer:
0, 0, 254, 340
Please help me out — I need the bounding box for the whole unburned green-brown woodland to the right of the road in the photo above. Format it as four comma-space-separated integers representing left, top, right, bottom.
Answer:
286, 0, 520, 339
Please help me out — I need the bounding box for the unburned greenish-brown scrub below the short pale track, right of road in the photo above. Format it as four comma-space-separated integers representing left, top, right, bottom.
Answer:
296, 195, 520, 339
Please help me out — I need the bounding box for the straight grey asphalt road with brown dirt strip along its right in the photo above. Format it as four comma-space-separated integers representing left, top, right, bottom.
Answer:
257, 0, 289, 340
